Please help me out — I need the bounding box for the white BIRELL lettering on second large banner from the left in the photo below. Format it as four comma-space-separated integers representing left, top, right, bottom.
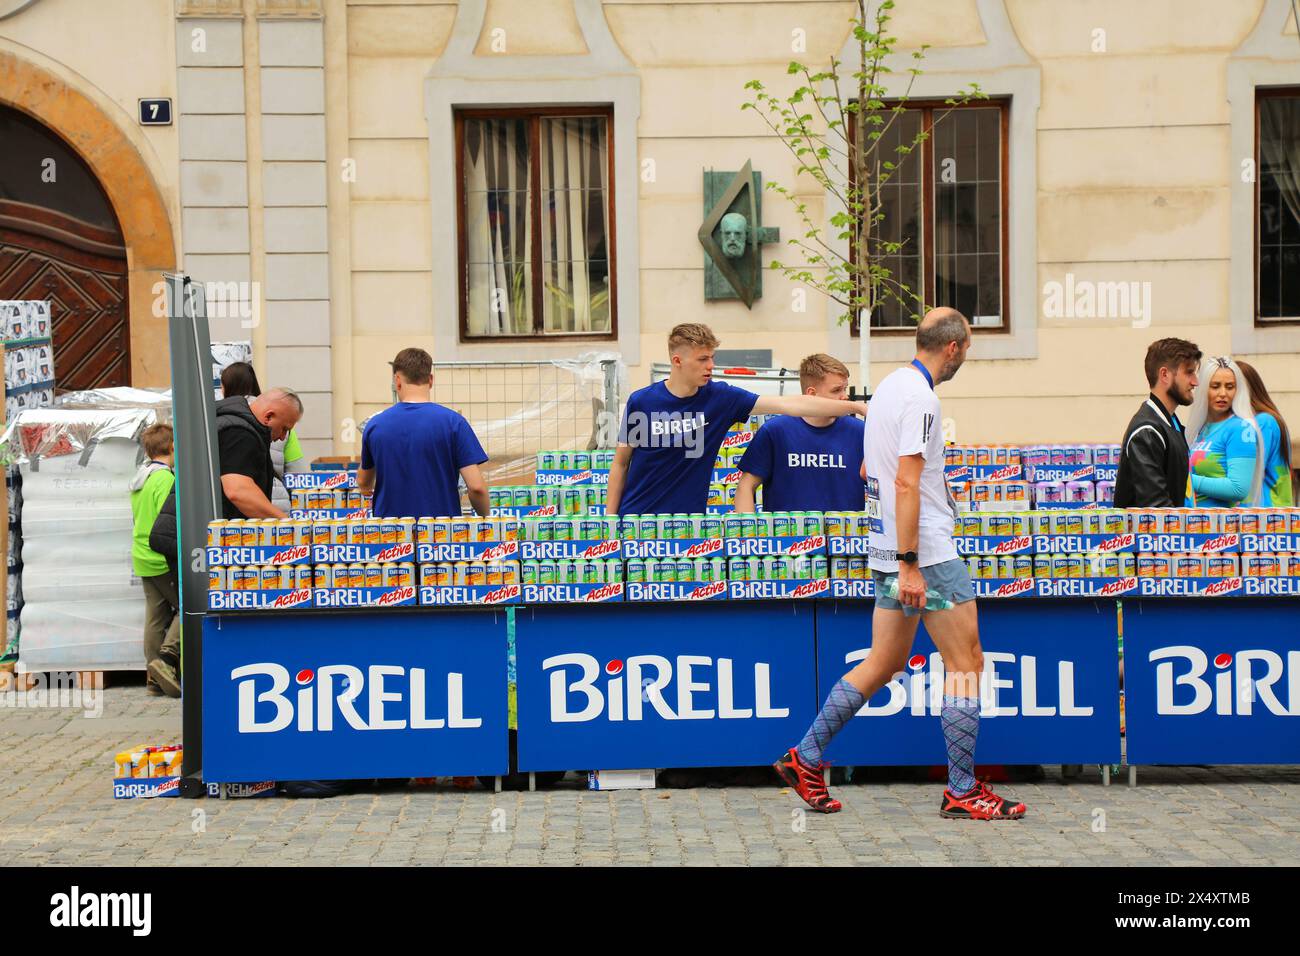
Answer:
542, 654, 790, 723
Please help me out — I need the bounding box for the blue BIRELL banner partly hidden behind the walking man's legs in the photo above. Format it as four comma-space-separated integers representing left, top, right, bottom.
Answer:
816, 601, 1119, 766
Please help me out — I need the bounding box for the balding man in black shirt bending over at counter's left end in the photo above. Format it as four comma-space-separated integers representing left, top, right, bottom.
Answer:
217, 388, 303, 518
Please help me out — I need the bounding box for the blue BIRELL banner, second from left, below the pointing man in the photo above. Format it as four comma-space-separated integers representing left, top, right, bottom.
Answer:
515, 601, 816, 771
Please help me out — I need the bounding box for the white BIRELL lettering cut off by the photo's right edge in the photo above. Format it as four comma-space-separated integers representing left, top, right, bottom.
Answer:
1148, 644, 1300, 717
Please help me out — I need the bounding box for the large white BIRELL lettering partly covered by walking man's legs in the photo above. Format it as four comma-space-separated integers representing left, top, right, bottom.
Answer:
844, 649, 1093, 717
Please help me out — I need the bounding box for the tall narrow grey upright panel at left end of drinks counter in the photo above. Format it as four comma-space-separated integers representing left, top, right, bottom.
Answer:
165, 274, 221, 797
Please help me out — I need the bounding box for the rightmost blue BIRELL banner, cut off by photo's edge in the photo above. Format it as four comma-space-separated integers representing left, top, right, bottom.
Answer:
1125, 598, 1300, 765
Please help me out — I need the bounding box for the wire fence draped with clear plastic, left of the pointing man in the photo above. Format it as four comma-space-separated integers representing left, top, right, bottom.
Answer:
433, 351, 627, 484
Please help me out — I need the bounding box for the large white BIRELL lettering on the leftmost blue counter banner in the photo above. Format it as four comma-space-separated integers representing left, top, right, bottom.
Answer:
230, 663, 482, 734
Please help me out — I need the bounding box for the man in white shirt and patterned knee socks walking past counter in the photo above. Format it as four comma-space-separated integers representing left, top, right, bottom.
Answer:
774, 308, 1024, 819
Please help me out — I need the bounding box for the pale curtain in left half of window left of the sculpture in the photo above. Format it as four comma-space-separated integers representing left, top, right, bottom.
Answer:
464, 120, 533, 336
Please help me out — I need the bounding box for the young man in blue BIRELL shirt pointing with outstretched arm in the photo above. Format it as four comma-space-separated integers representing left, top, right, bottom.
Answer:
606, 323, 867, 515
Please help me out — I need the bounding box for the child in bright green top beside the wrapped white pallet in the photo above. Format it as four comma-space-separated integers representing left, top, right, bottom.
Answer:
131, 425, 181, 697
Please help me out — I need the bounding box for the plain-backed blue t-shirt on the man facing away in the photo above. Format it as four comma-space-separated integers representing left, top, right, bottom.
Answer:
361, 402, 488, 518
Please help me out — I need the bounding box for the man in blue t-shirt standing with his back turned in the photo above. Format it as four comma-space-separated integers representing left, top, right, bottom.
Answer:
356, 349, 489, 518
